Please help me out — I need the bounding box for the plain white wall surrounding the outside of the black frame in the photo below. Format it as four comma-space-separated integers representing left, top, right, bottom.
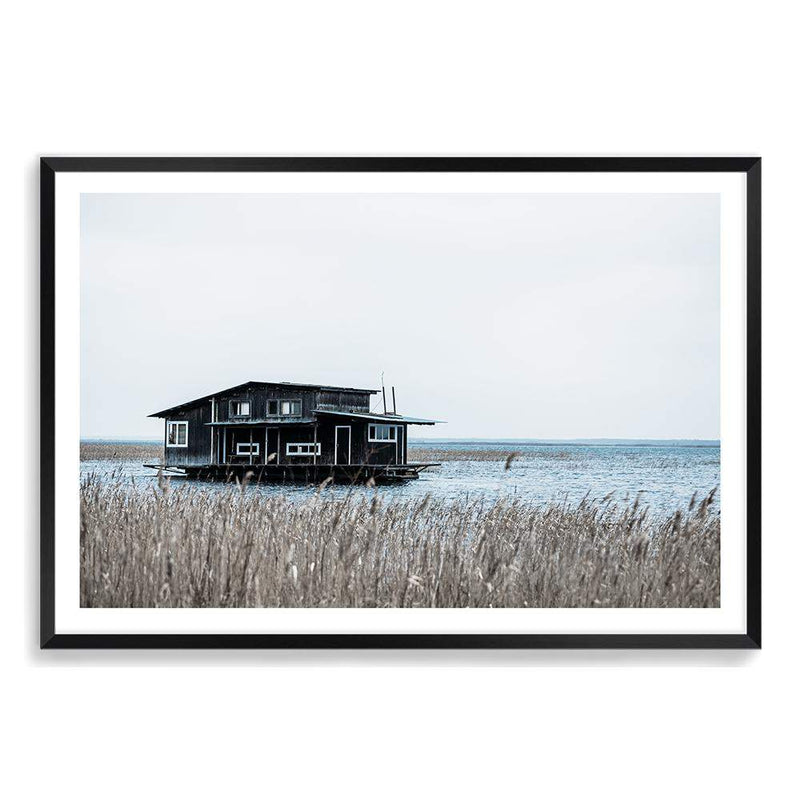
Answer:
0, 0, 800, 800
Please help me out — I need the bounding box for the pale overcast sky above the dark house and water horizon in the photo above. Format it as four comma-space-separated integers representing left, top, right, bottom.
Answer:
81, 194, 720, 438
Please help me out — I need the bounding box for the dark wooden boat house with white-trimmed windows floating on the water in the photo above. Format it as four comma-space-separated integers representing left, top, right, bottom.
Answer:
146, 381, 436, 481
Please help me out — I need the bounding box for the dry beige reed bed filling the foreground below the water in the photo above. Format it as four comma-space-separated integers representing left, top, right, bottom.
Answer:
80, 477, 720, 608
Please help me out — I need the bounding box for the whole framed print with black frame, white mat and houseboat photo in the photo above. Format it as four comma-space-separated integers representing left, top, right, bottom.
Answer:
41, 157, 761, 648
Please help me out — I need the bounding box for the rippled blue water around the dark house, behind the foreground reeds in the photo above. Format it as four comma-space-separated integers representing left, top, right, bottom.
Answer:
81, 440, 720, 515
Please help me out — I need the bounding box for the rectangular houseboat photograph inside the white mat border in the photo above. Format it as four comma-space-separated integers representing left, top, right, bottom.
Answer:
80, 181, 722, 608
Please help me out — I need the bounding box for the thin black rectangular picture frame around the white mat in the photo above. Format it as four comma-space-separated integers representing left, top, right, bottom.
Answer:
40, 156, 761, 650
